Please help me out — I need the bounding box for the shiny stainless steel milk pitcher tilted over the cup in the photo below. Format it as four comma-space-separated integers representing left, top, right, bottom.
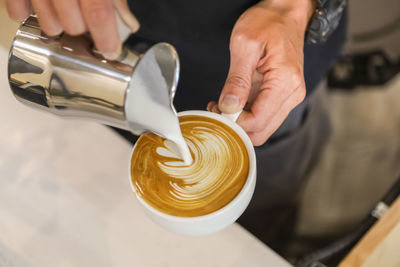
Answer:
8, 16, 179, 134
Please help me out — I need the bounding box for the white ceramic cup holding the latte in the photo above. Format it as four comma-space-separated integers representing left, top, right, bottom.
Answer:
129, 110, 257, 235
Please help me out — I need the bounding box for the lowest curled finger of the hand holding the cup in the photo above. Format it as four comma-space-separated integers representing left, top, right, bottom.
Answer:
248, 87, 305, 146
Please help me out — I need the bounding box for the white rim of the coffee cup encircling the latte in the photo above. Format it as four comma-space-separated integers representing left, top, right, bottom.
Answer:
129, 110, 256, 222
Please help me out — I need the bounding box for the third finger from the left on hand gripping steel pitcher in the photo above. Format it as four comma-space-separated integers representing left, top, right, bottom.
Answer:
52, 0, 86, 35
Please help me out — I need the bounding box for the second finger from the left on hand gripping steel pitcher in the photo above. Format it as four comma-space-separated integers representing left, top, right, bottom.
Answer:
32, 0, 63, 36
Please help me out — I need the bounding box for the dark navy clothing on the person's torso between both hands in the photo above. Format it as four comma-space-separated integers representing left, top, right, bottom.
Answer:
128, 0, 258, 110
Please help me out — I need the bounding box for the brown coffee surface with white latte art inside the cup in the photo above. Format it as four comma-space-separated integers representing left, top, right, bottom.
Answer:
131, 115, 249, 217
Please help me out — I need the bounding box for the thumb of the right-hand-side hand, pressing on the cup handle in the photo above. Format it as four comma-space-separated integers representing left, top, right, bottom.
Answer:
218, 34, 262, 113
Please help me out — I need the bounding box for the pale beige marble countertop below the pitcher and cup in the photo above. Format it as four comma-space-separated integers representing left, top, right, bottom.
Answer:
0, 47, 290, 267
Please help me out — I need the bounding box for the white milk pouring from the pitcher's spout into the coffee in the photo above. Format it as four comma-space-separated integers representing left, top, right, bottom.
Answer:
125, 48, 193, 165
